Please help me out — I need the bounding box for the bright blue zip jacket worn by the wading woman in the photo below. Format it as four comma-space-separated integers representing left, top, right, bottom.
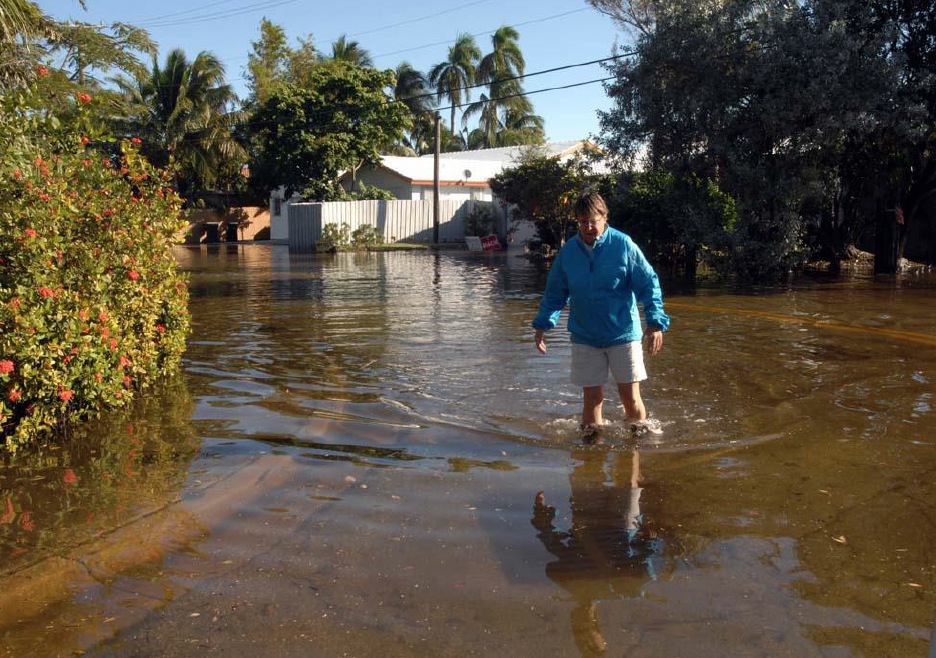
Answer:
532, 226, 670, 347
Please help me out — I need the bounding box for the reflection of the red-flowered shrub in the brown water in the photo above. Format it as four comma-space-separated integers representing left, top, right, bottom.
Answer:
0, 378, 198, 573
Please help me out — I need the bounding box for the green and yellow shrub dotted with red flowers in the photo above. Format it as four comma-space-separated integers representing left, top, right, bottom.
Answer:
0, 87, 189, 448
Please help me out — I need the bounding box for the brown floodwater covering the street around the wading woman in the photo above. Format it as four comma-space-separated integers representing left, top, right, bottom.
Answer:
0, 245, 936, 658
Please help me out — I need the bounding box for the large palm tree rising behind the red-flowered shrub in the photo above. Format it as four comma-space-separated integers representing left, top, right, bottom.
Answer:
114, 49, 245, 192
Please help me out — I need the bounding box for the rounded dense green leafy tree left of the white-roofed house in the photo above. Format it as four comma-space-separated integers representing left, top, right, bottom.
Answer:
251, 61, 410, 200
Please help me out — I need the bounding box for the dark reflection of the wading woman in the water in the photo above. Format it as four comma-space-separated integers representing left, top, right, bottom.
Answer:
531, 445, 662, 657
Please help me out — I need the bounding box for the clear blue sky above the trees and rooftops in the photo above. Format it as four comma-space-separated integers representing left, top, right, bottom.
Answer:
38, 0, 628, 141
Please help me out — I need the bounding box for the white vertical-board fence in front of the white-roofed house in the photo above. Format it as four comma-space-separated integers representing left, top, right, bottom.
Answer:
286, 200, 509, 251
